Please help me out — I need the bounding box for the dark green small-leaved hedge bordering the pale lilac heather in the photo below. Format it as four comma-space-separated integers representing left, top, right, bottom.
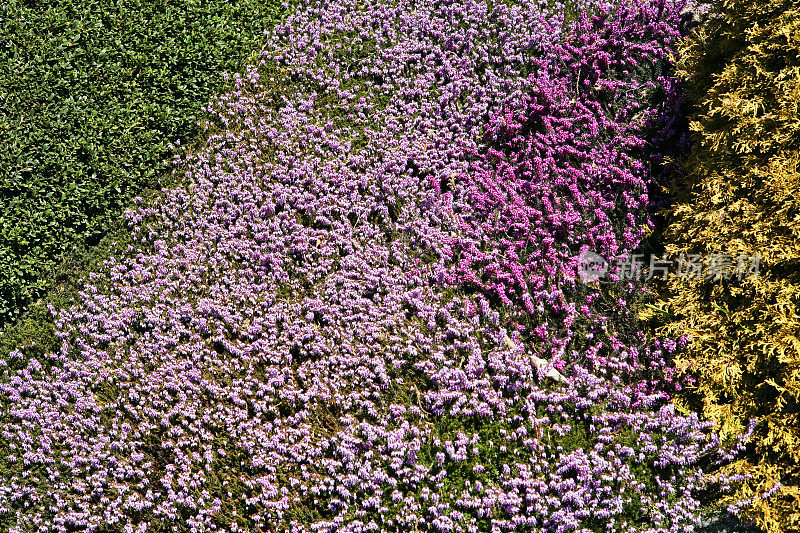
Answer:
0, 0, 292, 329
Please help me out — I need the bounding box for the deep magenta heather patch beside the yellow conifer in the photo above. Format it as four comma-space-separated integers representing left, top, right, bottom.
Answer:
438, 4, 692, 358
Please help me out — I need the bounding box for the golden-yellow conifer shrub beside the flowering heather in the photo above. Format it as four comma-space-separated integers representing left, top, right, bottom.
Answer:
648, 0, 800, 532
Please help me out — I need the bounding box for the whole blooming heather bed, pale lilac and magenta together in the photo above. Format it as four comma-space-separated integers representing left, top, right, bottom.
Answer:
0, 0, 740, 532
